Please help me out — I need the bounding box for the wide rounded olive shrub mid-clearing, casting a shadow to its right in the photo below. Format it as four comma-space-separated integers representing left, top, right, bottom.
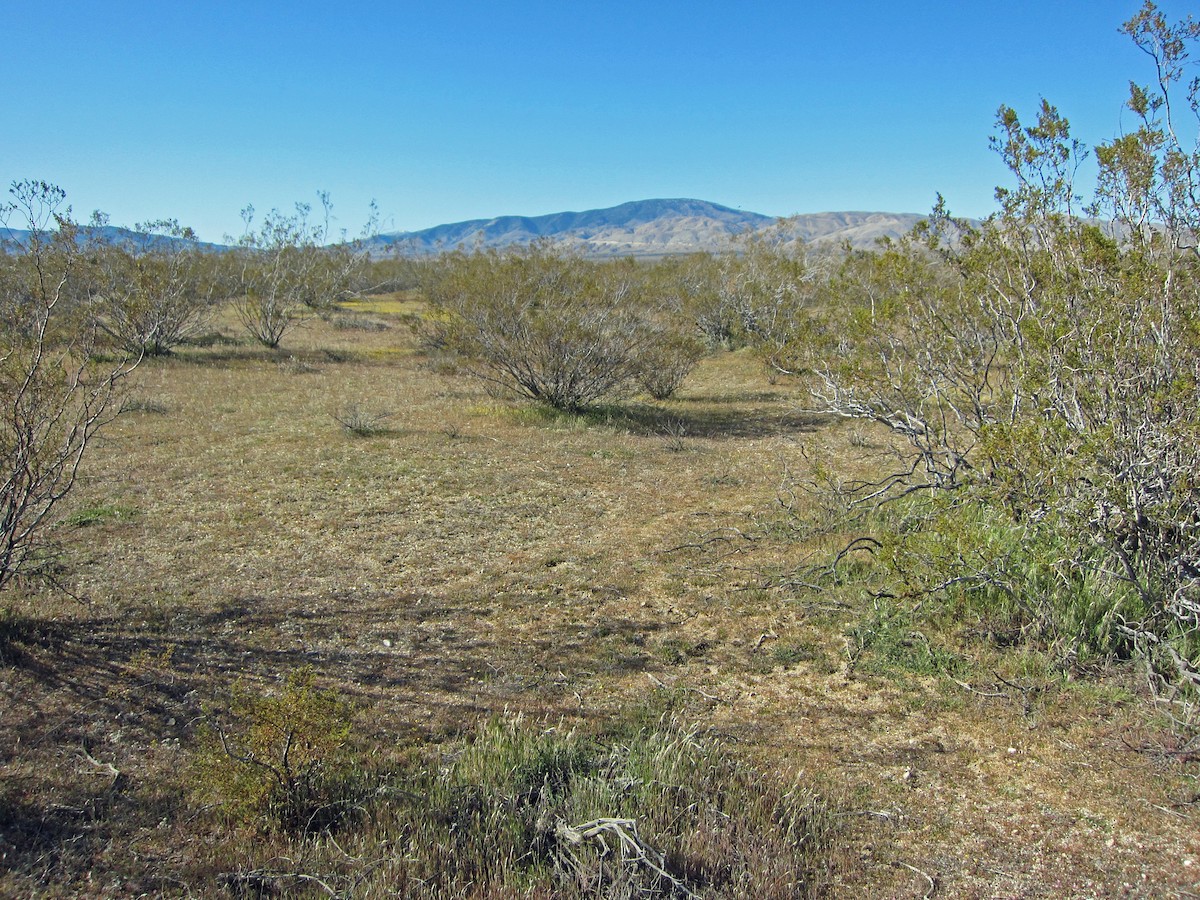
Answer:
425, 246, 695, 410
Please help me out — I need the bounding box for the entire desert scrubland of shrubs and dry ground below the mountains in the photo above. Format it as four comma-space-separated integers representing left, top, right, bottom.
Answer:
0, 5, 1200, 898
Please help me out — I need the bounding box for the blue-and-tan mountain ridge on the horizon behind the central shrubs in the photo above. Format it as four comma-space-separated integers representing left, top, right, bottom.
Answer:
368, 199, 924, 257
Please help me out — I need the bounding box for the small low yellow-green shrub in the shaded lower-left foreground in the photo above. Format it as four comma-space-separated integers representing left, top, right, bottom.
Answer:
193, 668, 361, 834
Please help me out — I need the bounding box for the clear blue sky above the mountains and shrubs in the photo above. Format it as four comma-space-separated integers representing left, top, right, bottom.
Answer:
7, 0, 1200, 240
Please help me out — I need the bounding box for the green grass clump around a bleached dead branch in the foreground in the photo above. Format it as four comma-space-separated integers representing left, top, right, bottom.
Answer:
338, 720, 834, 899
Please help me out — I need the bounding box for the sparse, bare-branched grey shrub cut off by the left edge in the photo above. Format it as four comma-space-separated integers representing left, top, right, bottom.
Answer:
0, 181, 138, 588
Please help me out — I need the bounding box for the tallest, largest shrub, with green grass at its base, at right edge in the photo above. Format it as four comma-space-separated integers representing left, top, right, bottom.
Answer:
803, 4, 1200, 688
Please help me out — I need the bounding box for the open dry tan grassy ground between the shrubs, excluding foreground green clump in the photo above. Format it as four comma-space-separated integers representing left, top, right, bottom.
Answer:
0, 295, 1200, 898
